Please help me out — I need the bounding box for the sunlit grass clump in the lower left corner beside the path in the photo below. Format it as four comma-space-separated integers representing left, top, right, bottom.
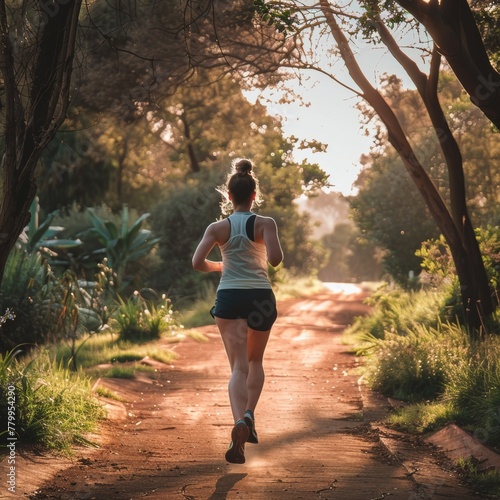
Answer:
0, 350, 105, 451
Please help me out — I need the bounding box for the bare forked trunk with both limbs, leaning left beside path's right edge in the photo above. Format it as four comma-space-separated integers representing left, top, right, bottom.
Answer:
321, 0, 496, 327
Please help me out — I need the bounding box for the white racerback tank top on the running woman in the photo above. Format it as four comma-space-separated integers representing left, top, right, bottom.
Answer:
218, 212, 271, 290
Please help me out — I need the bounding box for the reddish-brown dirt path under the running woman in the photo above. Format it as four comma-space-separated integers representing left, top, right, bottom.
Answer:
8, 292, 477, 500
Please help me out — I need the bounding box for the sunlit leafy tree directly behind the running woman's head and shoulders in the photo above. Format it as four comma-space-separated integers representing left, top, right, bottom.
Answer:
151, 78, 326, 297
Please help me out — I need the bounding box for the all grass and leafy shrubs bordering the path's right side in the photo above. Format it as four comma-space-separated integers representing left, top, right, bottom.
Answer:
344, 228, 500, 495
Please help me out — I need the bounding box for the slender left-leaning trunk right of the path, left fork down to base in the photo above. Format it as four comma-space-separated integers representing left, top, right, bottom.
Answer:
320, 0, 494, 327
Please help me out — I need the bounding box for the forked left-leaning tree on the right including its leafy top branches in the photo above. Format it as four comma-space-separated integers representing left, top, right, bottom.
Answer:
229, 0, 496, 327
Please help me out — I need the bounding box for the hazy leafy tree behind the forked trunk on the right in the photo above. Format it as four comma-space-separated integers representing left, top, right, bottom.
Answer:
351, 72, 500, 286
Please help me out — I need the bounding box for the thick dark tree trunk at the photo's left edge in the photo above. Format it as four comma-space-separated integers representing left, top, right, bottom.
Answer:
0, 0, 81, 282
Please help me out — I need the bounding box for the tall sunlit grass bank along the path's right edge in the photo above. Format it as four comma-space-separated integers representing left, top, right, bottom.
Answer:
351, 291, 500, 447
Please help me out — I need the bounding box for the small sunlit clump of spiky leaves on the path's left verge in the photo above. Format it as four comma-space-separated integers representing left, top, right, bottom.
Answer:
114, 290, 180, 342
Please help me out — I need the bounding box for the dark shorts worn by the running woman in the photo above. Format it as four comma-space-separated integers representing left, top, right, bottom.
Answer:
210, 288, 278, 332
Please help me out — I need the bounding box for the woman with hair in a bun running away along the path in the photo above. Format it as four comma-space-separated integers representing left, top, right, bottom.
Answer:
193, 159, 283, 464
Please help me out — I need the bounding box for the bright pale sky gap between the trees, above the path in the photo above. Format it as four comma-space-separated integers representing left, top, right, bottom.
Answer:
244, 26, 428, 195
